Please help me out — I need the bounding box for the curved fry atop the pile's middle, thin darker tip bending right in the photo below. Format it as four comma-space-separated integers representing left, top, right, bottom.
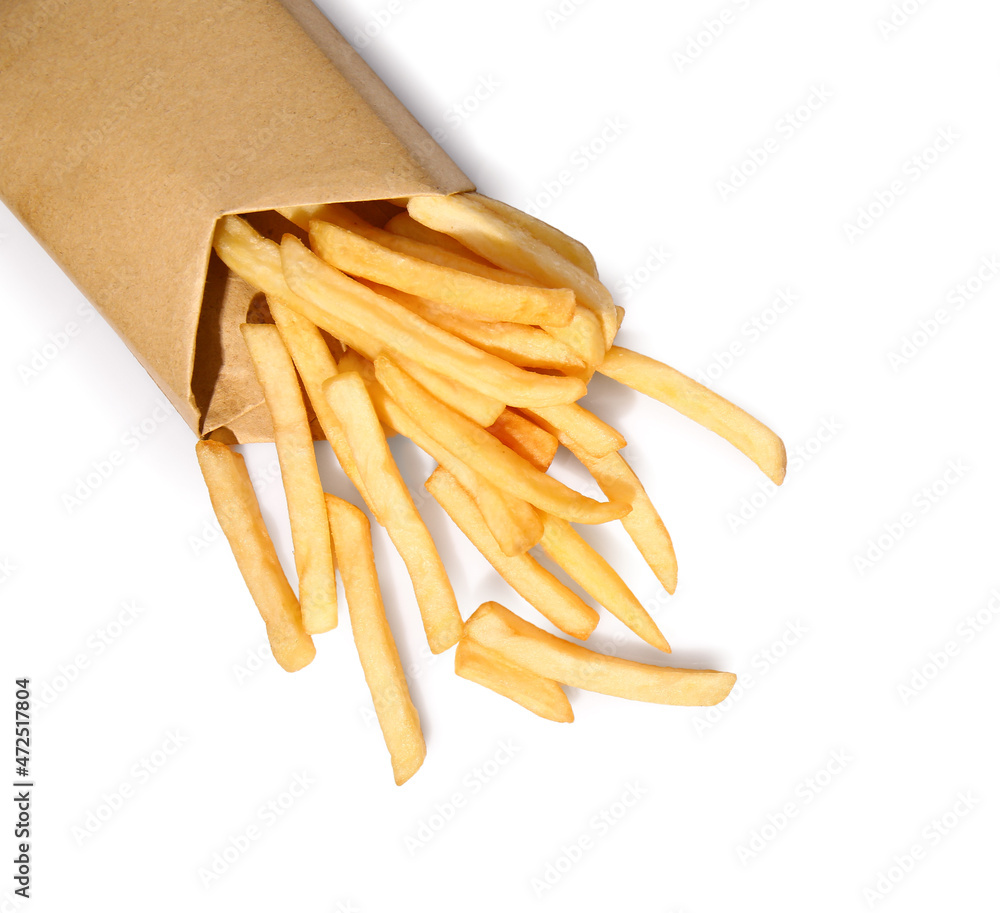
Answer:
375, 356, 629, 523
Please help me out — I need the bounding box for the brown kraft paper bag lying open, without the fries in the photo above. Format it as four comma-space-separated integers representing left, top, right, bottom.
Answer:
0, 0, 473, 443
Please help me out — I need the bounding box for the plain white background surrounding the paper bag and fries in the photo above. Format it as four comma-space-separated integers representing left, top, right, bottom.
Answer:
0, 0, 1000, 913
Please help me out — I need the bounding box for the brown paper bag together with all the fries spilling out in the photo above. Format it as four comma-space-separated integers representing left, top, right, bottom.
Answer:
0, 0, 785, 783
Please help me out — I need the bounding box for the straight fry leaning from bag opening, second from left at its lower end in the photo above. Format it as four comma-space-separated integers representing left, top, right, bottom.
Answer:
240, 323, 337, 634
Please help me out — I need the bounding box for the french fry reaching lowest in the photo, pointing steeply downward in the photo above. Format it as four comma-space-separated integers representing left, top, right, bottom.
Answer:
326, 494, 427, 786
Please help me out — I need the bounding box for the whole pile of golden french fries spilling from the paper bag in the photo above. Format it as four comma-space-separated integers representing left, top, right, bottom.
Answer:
197, 193, 785, 784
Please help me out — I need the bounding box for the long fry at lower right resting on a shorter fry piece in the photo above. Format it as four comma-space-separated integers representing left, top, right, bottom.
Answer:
465, 602, 736, 707
